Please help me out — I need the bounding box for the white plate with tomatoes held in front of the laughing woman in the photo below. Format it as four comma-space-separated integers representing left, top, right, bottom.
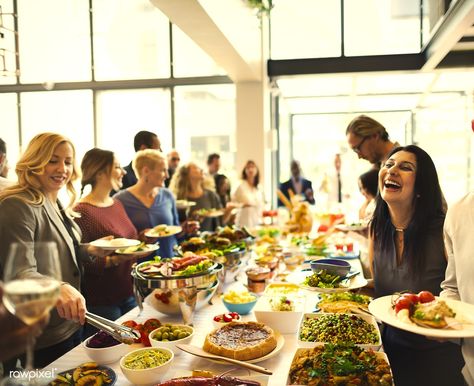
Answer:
369, 295, 474, 338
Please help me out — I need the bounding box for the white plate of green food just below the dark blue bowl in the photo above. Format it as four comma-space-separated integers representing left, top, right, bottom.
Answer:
287, 270, 367, 293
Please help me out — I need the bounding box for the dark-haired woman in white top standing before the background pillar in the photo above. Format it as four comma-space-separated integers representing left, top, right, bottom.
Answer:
232, 160, 265, 227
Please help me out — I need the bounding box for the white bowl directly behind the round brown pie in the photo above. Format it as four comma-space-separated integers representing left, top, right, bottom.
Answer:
253, 296, 304, 334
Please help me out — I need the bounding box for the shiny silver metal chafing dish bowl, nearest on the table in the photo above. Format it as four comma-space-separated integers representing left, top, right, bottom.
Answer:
132, 263, 223, 325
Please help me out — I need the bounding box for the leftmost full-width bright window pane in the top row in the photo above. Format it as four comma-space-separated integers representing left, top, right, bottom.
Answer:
17, 0, 91, 83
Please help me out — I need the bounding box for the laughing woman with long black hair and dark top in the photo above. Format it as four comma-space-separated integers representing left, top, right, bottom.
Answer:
369, 145, 464, 386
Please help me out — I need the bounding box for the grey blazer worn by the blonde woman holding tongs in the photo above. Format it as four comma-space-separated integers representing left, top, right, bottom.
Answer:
0, 197, 88, 349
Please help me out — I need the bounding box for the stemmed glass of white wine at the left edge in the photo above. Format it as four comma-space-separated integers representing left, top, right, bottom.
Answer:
3, 242, 61, 385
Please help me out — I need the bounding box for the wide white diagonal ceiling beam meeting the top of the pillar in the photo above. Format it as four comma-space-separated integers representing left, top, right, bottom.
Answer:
150, 0, 263, 82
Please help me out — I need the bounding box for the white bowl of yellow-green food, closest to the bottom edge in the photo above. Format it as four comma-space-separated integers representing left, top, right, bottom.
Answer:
120, 347, 174, 386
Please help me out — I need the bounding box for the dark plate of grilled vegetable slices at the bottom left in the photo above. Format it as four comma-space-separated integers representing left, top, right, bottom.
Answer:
48, 362, 117, 386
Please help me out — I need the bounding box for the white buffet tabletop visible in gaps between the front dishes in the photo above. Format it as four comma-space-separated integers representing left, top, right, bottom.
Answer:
46, 255, 362, 386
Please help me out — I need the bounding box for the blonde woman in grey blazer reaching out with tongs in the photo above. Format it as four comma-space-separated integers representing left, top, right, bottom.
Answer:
0, 133, 109, 368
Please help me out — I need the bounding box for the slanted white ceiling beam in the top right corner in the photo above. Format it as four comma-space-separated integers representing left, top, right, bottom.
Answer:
422, 0, 474, 71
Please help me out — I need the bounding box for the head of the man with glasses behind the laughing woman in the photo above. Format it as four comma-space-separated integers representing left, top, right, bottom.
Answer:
346, 115, 400, 169
